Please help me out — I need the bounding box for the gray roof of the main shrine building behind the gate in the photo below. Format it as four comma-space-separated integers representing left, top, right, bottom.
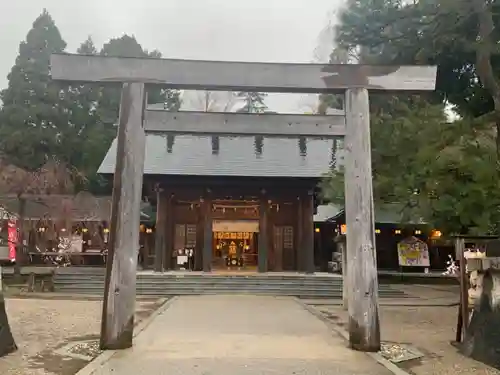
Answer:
98, 134, 333, 178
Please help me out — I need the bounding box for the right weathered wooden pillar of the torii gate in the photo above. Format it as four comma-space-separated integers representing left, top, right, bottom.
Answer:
345, 89, 380, 352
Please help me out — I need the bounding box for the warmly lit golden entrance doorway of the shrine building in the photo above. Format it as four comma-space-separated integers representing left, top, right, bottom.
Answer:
212, 220, 259, 271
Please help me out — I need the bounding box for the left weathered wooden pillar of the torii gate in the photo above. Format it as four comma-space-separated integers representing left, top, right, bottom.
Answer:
100, 83, 146, 349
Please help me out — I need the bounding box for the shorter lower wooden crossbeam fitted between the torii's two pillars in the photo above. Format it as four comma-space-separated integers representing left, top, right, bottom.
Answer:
144, 110, 345, 138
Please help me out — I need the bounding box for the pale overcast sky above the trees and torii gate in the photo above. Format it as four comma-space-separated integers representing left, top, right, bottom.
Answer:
0, 0, 341, 112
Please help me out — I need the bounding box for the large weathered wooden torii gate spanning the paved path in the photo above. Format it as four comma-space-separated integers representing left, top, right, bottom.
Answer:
51, 54, 437, 351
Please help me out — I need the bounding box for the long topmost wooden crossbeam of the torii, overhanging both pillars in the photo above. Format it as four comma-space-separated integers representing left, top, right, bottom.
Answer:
50, 54, 437, 93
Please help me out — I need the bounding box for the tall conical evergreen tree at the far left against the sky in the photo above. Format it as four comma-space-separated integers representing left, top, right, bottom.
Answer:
0, 10, 68, 170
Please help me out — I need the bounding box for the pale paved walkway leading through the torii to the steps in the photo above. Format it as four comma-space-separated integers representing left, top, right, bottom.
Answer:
87, 296, 390, 375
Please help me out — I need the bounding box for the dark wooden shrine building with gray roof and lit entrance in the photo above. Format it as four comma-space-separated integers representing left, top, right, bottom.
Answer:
99, 109, 336, 273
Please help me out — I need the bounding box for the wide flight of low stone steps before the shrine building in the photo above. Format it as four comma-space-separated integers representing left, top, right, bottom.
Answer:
54, 269, 406, 300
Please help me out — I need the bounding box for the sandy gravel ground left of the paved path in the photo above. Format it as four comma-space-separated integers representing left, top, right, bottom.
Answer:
0, 298, 163, 375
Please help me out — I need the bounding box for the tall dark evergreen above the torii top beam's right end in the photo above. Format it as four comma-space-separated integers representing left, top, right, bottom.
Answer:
335, 0, 500, 154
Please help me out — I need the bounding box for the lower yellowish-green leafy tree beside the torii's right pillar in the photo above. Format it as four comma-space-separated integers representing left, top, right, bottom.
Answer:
322, 97, 500, 234
